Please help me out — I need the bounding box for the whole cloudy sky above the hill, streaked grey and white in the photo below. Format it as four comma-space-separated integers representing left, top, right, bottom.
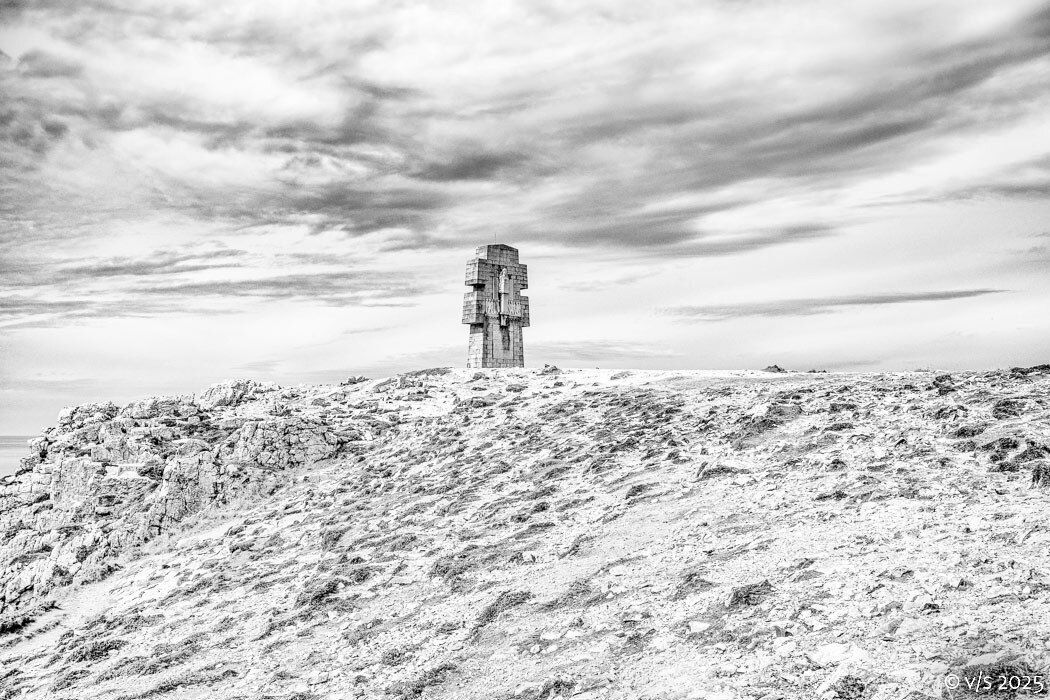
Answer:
0, 0, 1050, 433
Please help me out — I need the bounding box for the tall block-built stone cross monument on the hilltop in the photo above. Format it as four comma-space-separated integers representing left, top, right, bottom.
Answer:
463, 243, 528, 367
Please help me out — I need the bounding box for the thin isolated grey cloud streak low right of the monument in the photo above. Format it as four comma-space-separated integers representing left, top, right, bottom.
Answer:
664, 290, 1005, 321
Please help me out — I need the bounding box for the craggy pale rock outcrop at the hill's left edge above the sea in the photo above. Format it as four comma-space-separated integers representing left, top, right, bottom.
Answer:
0, 381, 371, 628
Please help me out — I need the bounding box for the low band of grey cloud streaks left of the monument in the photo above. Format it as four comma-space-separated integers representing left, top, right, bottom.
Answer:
0, 238, 435, 327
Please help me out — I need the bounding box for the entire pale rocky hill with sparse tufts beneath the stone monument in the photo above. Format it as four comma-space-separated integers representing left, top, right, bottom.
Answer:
0, 365, 1050, 700
